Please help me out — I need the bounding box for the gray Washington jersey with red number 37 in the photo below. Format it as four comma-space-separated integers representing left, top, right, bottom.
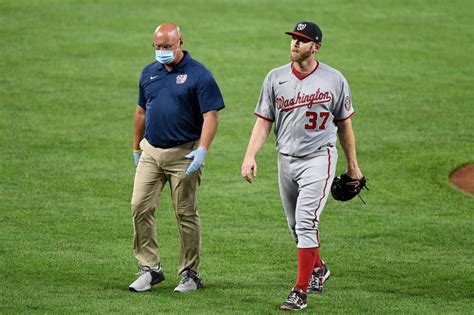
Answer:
255, 62, 354, 157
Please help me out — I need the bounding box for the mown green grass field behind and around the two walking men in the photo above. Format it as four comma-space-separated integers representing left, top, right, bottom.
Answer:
0, 0, 474, 314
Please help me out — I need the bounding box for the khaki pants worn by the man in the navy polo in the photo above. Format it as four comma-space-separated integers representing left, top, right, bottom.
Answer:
132, 139, 201, 274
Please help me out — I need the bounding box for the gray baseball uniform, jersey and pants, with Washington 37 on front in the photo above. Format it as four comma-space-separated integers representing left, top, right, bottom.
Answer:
255, 62, 354, 248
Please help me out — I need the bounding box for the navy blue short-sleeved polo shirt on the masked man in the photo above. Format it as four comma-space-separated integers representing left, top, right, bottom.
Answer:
138, 51, 224, 148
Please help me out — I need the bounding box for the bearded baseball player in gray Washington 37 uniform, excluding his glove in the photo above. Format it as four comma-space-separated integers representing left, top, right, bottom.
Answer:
242, 22, 362, 311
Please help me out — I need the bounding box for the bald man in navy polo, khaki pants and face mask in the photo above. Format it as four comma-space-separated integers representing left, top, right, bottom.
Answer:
129, 23, 224, 292
